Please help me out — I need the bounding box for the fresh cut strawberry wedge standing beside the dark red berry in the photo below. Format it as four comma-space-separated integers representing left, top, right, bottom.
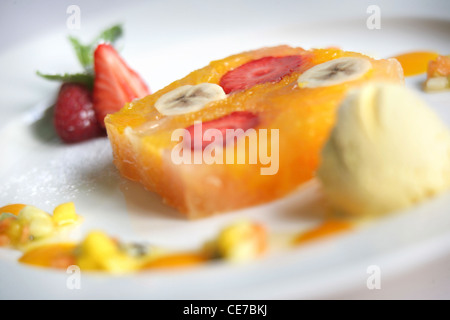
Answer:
93, 43, 150, 127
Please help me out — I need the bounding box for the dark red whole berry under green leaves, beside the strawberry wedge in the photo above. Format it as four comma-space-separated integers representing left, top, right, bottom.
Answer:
53, 83, 103, 143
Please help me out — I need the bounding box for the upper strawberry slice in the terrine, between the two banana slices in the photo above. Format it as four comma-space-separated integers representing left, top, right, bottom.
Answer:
220, 56, 305, 94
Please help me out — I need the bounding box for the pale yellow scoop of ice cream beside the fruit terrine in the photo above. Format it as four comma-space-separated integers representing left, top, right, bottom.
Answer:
318, 83, 450, 215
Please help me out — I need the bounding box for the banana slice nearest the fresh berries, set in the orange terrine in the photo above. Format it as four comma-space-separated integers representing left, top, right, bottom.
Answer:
155, 83, 227, 116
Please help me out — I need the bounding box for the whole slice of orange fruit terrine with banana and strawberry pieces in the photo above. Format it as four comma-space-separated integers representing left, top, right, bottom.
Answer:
105, 46, 403, 218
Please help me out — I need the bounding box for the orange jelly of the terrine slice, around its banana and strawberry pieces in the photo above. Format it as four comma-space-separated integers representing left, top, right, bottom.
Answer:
105, 46, 403, 218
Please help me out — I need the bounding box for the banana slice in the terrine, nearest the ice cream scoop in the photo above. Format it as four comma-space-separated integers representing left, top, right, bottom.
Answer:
297, 57, 372, 88
